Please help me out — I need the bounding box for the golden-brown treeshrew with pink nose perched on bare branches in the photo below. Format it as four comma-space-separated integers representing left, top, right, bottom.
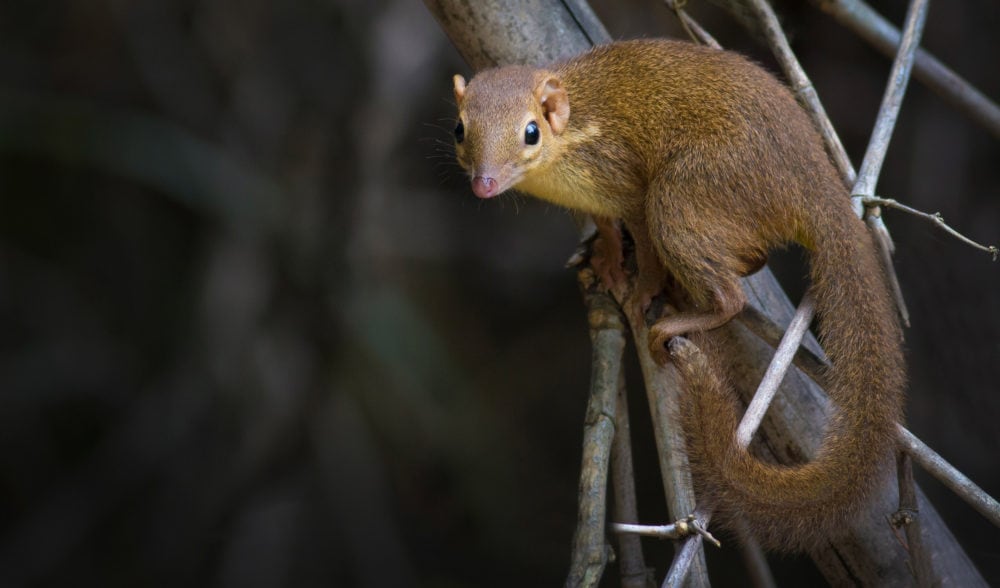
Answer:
455, 41, 904, 549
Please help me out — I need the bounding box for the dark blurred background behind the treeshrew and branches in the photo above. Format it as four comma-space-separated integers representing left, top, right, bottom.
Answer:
0, 0, 1000, 587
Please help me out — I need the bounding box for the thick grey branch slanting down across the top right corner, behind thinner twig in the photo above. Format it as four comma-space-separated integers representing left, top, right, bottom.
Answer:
812, 0, 1000, 137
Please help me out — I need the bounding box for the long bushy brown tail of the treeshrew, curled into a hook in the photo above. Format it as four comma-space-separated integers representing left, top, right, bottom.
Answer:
671, 210, 905, 551
